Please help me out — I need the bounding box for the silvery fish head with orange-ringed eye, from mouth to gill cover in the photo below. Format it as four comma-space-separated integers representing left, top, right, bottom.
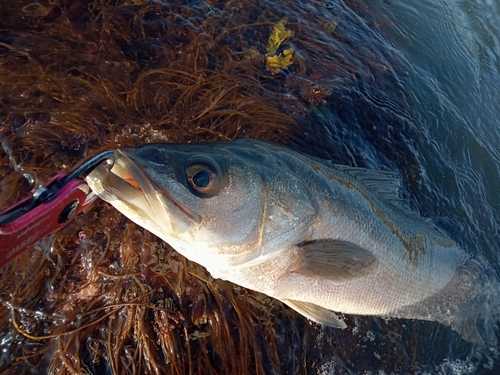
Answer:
87, 143, 312, 271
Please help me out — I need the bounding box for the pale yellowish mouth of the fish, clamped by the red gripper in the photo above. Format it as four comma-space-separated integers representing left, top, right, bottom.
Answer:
86, 150, 201, 237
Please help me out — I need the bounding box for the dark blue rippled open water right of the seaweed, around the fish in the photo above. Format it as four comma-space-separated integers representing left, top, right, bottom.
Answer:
291, 0, 500, 374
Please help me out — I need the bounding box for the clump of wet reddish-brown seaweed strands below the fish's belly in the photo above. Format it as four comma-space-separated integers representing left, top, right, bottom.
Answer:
1, 206, 290, 374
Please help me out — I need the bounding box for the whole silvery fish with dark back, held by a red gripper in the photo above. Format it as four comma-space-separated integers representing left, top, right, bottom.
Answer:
87, 139, 496, 341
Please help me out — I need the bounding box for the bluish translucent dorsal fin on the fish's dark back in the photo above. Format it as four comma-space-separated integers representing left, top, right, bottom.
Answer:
335, 164, 402, 206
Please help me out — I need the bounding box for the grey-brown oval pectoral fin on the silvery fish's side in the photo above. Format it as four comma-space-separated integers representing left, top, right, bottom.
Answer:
293, 240, 377, 282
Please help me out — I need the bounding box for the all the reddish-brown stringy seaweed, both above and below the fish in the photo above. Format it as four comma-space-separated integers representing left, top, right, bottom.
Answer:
0, 0, 414, 374
